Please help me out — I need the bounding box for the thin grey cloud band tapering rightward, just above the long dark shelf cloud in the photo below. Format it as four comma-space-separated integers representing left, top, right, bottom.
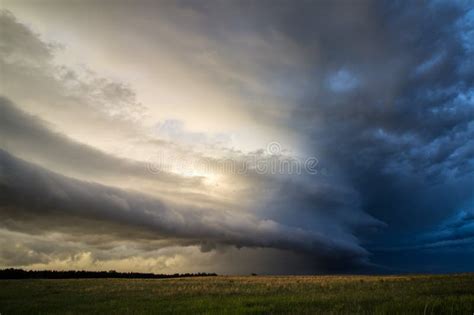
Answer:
0, 97, 200, 187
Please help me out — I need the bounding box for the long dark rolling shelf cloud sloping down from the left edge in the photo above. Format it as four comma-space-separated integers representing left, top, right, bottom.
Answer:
0, 151, 367, 261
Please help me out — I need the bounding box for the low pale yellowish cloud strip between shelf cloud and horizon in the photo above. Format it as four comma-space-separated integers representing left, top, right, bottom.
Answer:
0, 229, 350, 274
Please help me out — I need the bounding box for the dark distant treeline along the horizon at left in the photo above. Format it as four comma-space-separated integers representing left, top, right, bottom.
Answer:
0, 268, 217, 279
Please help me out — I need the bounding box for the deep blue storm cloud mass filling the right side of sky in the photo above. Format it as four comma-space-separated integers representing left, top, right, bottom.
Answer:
286, 2, 474, 260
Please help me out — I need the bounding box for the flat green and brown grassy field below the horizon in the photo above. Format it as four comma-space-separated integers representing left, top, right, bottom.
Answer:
0, 274, 474, 315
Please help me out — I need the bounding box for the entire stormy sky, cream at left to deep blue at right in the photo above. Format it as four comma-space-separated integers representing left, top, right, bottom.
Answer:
0, 0, 474, 274
